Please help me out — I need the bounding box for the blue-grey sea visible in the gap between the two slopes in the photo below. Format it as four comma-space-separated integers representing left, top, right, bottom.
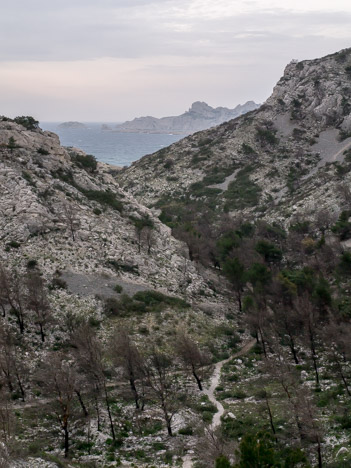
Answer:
40, 122, 184, 166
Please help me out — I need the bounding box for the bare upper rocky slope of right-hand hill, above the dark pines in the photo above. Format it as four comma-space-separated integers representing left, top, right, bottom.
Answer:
118, 49, 351, 229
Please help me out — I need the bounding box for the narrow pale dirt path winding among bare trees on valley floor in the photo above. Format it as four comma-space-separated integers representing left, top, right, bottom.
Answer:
183, 340, 256, 468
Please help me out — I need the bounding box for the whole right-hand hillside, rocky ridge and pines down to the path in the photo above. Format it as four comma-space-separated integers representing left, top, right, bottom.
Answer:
117, 49, 351, 467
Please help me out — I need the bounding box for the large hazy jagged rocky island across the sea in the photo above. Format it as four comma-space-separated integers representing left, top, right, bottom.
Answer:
113, 101, 259, 135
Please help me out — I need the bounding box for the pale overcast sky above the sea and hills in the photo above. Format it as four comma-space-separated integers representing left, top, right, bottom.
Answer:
0, 0, 351, 122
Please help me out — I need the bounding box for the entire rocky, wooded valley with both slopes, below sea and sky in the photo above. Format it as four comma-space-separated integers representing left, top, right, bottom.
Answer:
0, 49, 351, 468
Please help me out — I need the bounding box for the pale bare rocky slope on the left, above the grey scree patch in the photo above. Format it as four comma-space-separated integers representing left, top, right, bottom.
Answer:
0, 121, 212, 292
